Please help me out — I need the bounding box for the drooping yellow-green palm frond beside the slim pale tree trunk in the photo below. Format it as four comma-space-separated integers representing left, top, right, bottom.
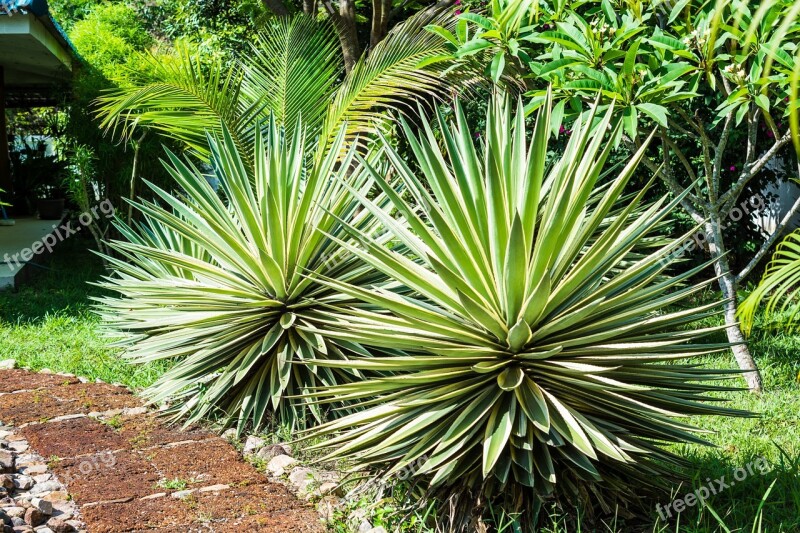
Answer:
738, 231, 800, 333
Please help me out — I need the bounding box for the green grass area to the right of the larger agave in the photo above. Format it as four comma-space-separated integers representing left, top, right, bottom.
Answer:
656, 310, 800, 532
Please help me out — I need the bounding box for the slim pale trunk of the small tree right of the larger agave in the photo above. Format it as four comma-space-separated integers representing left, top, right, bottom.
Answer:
705, 213, 764, 393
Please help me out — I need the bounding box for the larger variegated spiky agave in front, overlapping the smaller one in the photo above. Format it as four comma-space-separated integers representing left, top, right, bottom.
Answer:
298, 93, 743, 522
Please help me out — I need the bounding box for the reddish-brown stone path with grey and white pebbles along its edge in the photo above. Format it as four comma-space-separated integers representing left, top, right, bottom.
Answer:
0, 370, 324, 533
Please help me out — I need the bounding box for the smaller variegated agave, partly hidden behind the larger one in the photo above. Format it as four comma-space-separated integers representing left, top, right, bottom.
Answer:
93, 122, 388, 431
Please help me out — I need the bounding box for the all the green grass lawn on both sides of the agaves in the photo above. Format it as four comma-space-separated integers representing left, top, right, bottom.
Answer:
0, 239, 800, 532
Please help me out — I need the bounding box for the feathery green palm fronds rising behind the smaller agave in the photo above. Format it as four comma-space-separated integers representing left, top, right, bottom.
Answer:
97, 9, 462, 165
